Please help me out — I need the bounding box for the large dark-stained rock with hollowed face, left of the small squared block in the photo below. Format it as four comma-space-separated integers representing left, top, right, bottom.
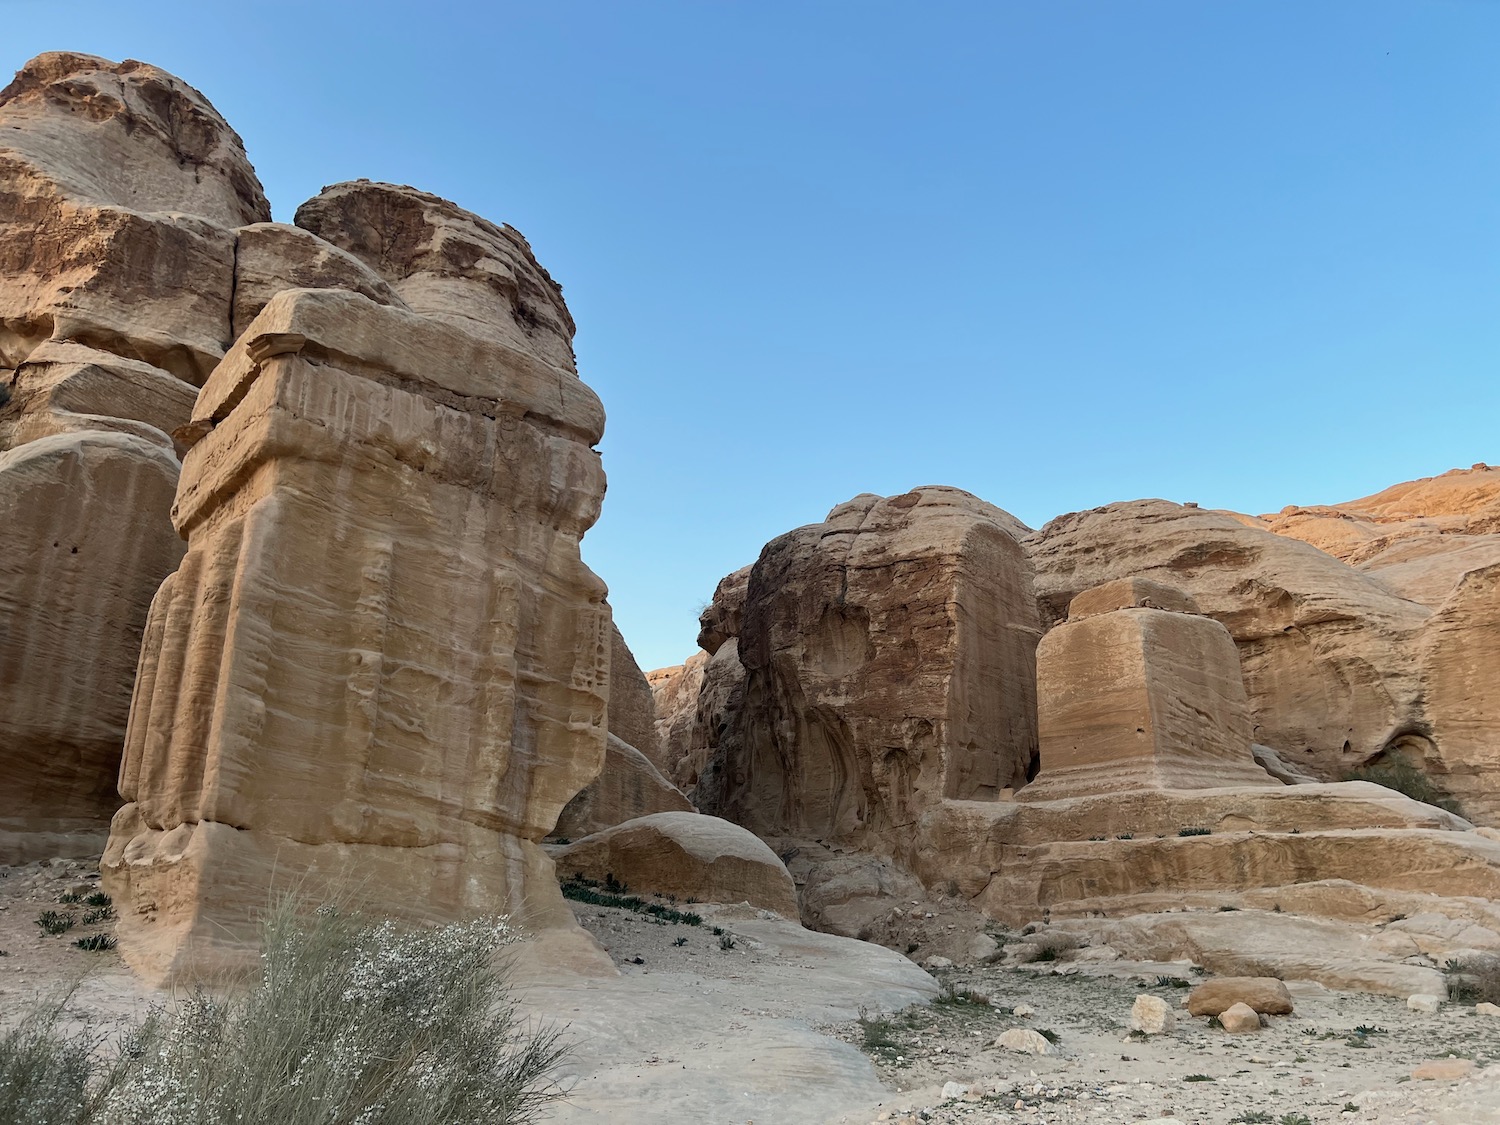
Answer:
698, 488, 1038, 840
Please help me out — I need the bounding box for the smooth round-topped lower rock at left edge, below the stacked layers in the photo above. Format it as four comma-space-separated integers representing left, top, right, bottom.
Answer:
0, 432, 183, 864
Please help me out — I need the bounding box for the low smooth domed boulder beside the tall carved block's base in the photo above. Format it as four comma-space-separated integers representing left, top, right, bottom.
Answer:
554, 813, 798, 920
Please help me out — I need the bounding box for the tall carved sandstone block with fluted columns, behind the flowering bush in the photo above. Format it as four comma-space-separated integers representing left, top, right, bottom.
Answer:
104, 290, 611, 978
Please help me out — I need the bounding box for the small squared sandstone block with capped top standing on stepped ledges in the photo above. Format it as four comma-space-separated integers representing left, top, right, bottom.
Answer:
1019, 584, 1280, 801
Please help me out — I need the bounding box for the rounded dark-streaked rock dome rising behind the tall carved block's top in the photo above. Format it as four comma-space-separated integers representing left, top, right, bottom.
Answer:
297, 180, 578, 374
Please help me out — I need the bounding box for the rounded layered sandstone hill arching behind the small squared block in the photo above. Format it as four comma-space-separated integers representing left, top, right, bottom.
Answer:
1029, 500, 1430, 779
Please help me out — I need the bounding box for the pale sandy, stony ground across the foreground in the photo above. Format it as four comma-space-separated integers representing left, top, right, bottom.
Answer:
0, 863, 1500, 1125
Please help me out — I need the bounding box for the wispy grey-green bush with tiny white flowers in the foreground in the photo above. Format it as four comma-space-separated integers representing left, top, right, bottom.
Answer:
0, 902, 564, 1125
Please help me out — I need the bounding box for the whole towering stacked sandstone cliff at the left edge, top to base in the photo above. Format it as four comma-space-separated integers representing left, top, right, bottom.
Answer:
0, 53, 270, 863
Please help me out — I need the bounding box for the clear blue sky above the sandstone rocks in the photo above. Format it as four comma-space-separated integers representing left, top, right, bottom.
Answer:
0, 0, 1500, 669
